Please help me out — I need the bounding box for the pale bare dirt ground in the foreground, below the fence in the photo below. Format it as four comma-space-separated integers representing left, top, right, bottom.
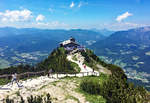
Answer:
0, 76, 86, 103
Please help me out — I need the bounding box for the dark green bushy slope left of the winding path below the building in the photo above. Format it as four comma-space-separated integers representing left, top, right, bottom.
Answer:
38, 48, 80, 73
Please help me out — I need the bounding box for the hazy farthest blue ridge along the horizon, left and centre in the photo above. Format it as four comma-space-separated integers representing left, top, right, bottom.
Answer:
0, 27, 105, 45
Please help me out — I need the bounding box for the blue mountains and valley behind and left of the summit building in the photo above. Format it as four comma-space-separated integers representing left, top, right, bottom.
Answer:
0, 27, 105, 68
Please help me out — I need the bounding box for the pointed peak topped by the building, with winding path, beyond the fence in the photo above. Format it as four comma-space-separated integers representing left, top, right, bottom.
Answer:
38, 38, 111, 74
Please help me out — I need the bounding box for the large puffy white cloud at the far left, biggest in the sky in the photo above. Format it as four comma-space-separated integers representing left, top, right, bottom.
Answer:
0, 9, 32, 22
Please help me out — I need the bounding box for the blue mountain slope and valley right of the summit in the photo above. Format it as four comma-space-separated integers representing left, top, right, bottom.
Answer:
90, 27, 150, 88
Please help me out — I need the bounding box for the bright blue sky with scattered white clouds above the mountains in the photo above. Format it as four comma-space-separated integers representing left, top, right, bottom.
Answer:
0, 0, 150, 30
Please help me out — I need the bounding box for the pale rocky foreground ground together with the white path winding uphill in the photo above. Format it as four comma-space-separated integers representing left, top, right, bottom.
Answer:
0, 52, 108, 103
